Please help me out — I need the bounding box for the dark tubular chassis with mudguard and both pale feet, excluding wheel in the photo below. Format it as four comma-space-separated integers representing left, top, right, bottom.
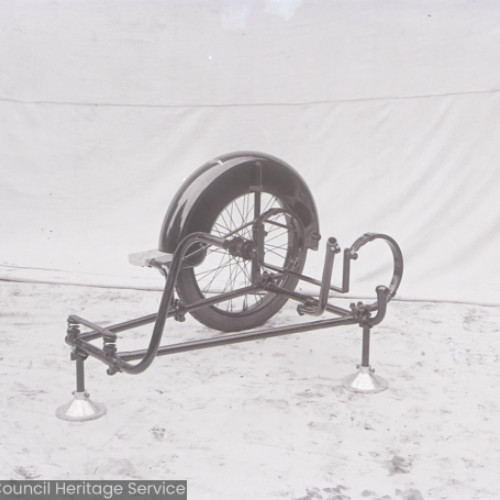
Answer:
56, 152, 403, 421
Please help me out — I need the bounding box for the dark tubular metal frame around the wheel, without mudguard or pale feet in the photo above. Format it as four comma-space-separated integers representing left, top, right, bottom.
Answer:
61, 233, 403, 394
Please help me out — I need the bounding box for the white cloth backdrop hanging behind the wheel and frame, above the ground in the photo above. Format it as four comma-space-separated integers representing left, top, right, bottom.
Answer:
0, 0, 500, 304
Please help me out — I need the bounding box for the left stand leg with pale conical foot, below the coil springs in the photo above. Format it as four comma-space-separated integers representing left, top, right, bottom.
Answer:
56, 353, 106, 422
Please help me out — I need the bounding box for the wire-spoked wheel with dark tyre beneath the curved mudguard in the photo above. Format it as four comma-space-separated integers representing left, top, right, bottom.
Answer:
176, 186, 307, 332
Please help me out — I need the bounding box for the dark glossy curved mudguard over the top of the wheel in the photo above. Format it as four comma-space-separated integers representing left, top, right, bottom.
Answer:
159, 151, 321, 253
